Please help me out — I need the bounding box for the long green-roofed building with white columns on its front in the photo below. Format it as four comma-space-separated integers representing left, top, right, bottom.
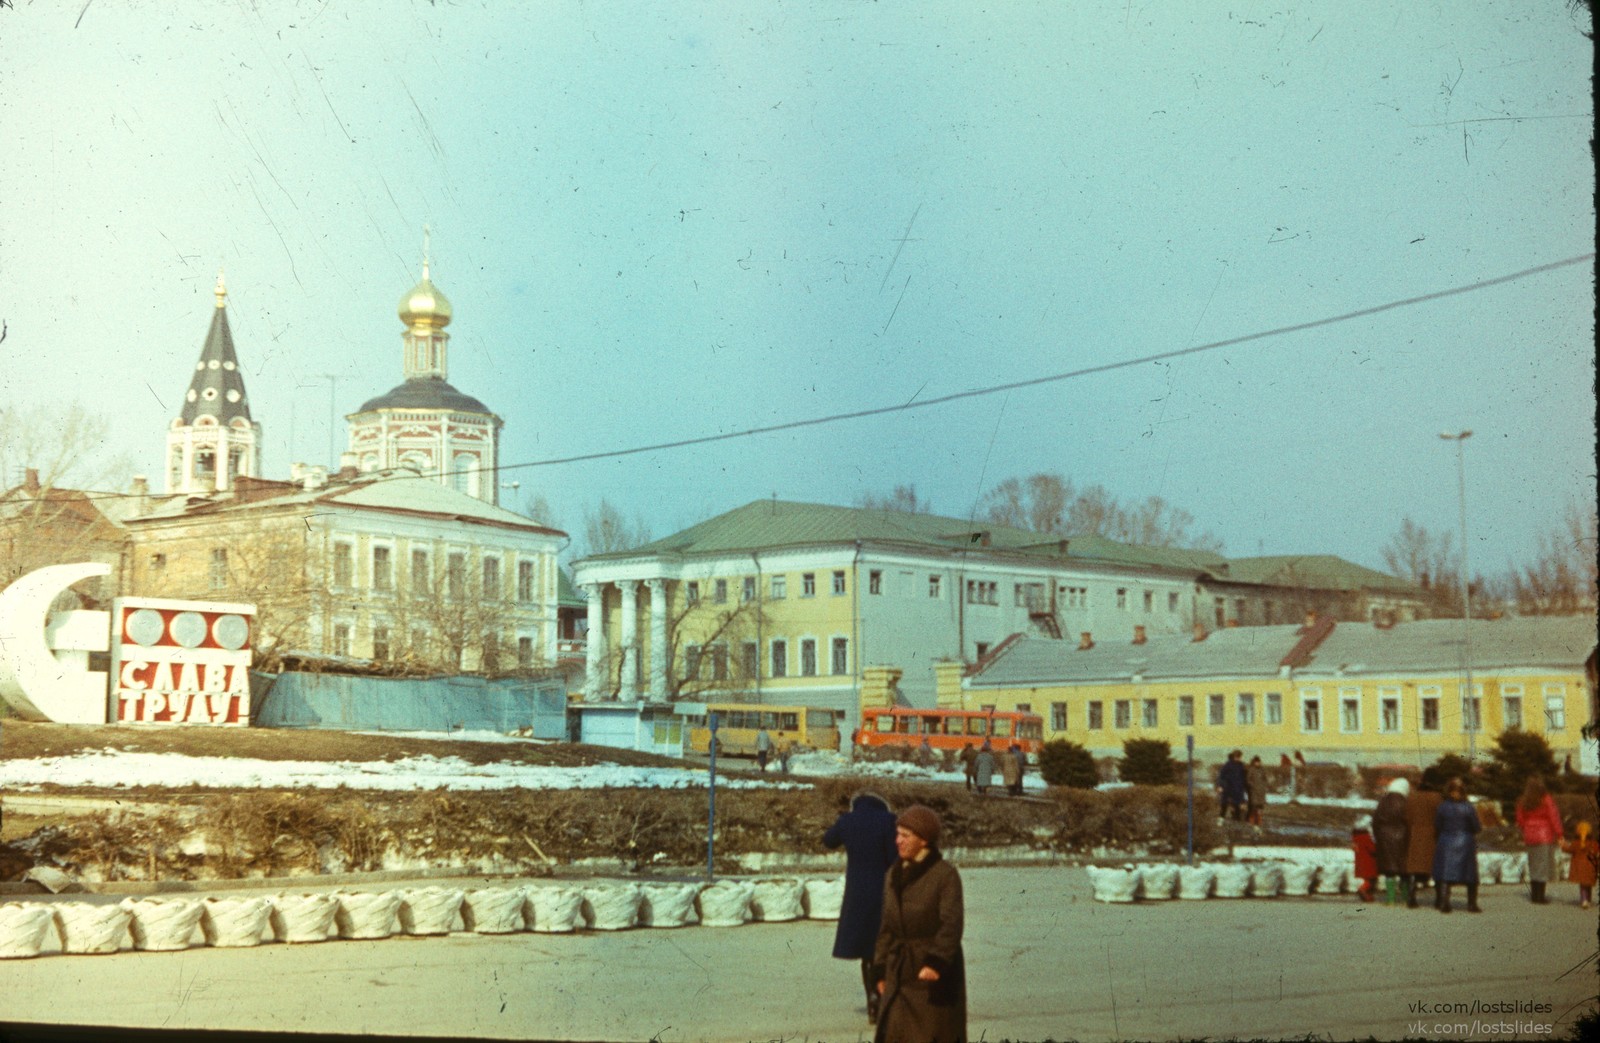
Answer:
574, 499, 1414, 735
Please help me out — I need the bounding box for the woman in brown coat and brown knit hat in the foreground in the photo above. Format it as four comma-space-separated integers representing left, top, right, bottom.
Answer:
874, 805, 966, 1043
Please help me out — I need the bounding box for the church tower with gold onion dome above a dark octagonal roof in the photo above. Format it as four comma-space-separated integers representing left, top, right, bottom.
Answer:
346, 251, 502, 504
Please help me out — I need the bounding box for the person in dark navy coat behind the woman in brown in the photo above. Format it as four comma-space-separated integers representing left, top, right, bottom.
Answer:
822, 790, 899, 1025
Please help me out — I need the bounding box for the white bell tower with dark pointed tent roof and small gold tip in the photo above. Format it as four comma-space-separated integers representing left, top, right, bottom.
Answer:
166, 272, 261, 494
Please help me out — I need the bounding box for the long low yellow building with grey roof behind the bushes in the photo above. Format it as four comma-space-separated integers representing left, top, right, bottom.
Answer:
960, 616, 1595, 768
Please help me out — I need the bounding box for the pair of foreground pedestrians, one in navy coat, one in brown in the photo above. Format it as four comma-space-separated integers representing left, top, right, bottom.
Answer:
822, 792, 966, 1043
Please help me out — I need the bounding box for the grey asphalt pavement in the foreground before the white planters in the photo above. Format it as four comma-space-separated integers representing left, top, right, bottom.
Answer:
0, 867, 1597, 1043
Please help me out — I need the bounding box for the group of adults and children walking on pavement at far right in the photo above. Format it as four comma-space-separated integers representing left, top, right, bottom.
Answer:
1350, 768, 1600, 913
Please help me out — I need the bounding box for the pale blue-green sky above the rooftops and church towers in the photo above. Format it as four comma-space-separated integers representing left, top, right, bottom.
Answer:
0, 0, 1595, 571
